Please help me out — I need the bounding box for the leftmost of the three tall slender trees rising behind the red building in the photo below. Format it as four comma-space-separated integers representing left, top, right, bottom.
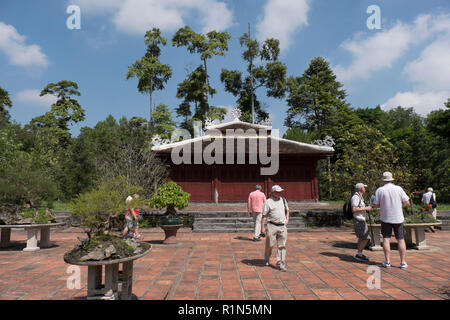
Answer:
126, 28, 172, 126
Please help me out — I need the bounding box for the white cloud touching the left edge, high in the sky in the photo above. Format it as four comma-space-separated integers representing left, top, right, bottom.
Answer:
0, 21, 48, 67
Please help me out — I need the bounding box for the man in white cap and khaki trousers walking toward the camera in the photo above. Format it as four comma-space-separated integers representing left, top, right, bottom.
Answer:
261, 185, 289, 271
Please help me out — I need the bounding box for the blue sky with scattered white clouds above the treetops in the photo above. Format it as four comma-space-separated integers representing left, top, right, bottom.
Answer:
0, 0, 450, 135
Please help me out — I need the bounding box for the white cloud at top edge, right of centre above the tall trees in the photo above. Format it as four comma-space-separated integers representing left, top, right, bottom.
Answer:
256, 0, 310, 50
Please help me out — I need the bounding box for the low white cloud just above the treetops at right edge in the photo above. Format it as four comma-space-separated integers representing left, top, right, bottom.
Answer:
381, 91, 450, 116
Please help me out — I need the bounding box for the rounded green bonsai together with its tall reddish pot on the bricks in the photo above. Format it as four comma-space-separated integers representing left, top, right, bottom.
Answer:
149, 182, 191, 244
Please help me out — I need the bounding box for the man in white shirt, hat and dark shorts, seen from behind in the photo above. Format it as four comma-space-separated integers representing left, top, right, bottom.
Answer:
373, 172, 409, 269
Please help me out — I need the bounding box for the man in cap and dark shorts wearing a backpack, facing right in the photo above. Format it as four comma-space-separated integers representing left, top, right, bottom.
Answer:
351, 183, 372, 262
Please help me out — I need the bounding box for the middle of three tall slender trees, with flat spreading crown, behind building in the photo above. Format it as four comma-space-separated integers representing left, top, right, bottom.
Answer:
172, 26, 231, 109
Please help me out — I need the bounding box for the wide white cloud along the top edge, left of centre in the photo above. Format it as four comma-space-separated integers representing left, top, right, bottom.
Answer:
75, 0, 233, 34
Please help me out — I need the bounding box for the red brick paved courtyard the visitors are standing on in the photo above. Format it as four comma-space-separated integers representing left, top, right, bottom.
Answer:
0, 228, 450, 300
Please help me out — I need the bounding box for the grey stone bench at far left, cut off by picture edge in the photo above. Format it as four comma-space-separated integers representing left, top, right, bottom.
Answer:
0, 222, 65, 251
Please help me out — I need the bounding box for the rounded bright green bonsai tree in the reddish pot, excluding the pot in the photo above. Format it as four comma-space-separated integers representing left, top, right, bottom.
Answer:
149, 182, 191, 217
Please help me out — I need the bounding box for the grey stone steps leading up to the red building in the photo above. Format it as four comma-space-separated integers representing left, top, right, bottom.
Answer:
192, 211, 306, 233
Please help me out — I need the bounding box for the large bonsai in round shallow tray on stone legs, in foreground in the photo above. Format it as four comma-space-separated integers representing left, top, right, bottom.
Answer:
64, 177, 151, 299
